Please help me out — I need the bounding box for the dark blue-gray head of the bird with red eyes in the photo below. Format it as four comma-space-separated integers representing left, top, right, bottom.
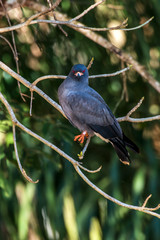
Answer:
69, 64, 88, 83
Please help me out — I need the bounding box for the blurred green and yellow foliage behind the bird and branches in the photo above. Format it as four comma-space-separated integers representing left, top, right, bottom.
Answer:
0, 0, 160, 240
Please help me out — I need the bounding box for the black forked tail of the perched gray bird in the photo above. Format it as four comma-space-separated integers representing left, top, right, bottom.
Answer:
109, 135, 139, 165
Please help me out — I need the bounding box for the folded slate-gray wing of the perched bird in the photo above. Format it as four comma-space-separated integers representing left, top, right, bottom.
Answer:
66, 92, 122, 139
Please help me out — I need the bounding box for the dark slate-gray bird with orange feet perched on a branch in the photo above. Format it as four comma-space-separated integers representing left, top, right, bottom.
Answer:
58, 64, 139, 165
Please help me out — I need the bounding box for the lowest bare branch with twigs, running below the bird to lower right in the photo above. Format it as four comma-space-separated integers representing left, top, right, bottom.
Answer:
0, 86, 160, 219
